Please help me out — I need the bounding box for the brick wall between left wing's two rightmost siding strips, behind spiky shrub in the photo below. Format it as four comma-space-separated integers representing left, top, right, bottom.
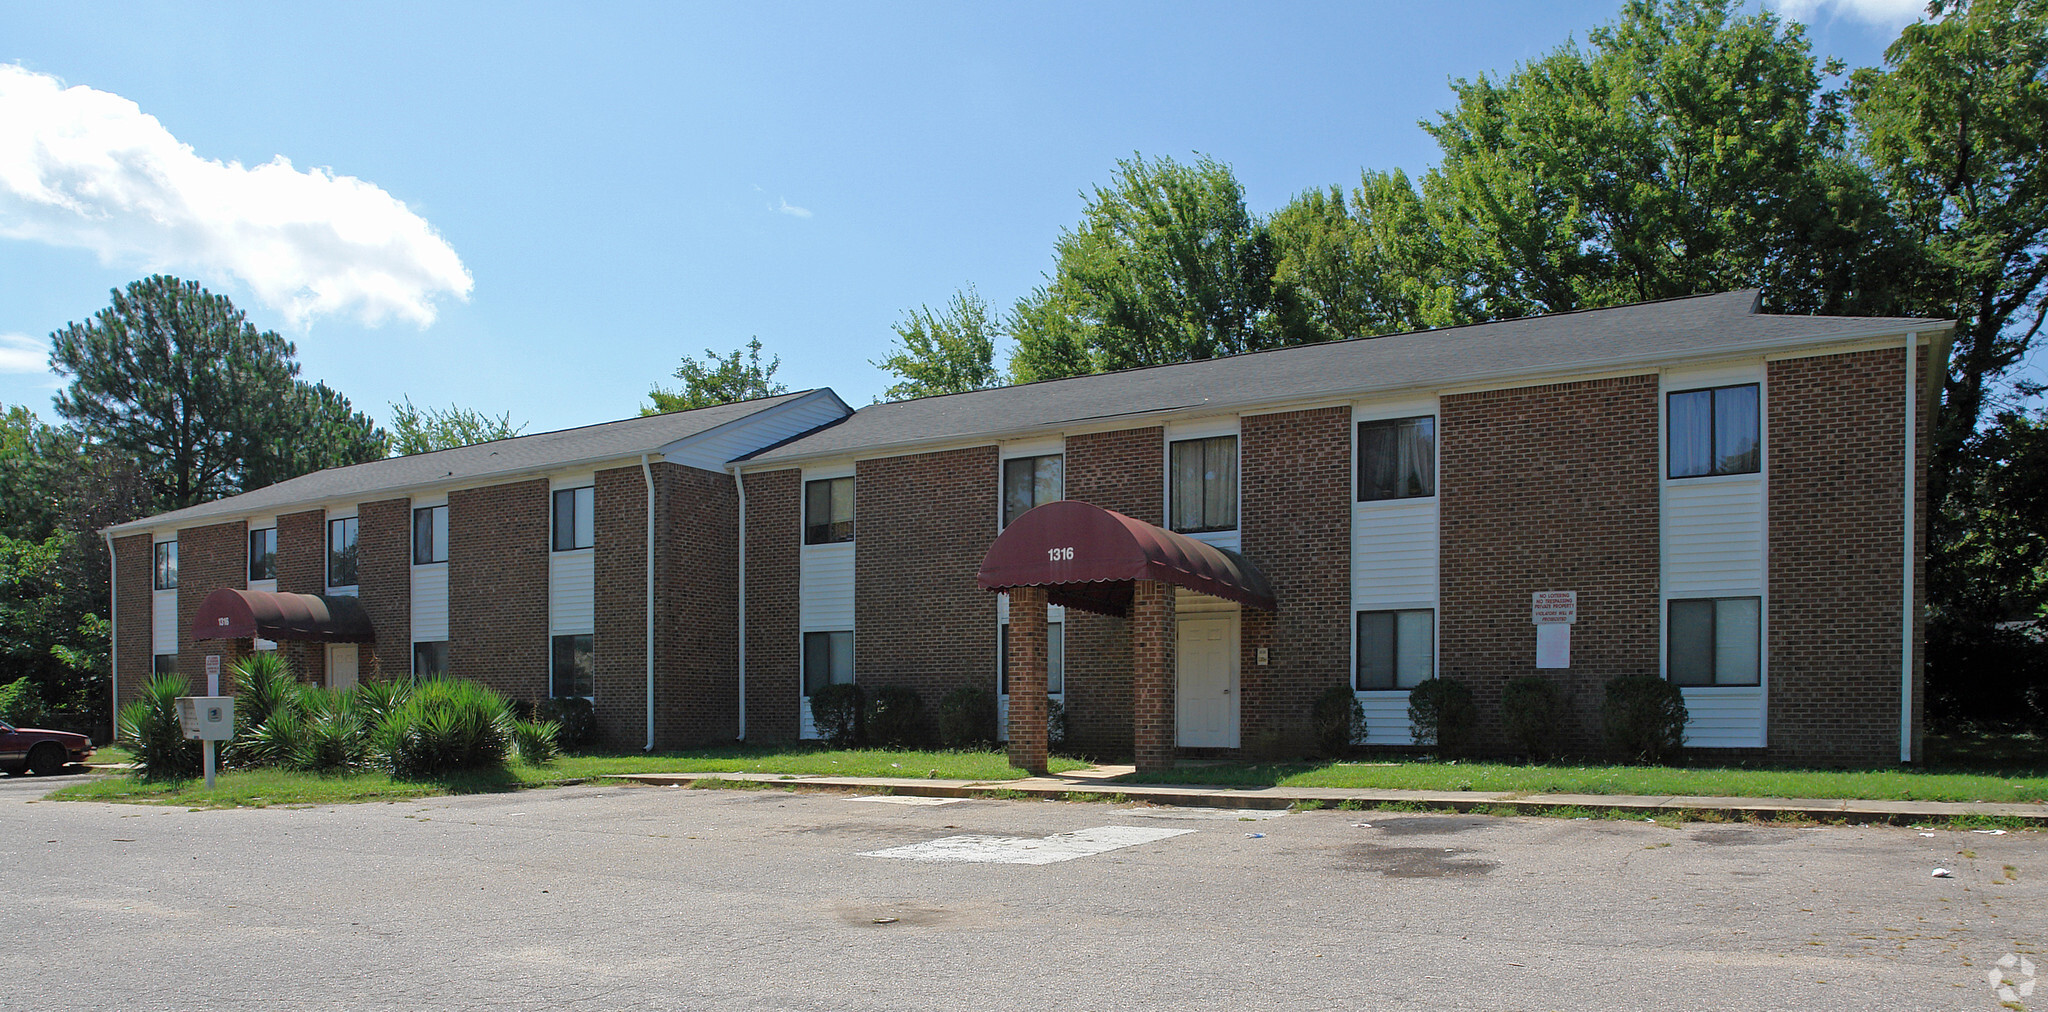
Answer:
446, 477, 549, 699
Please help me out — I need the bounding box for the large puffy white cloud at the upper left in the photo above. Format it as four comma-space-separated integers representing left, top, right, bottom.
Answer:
0, 64, 473, 328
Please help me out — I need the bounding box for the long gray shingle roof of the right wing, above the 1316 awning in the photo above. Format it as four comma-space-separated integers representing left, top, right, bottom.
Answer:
754, 289, 1950, 463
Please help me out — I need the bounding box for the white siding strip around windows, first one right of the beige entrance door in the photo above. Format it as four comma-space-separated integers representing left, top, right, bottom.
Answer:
1350, 397, 1444, 746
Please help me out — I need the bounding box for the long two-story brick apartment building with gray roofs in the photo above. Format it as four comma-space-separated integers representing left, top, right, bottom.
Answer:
109, 291, 1950, 762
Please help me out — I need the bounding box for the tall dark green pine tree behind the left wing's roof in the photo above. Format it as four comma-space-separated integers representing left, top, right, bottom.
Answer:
49, 275, 387, 508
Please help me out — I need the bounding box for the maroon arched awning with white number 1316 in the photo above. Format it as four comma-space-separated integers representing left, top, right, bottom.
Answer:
975, 500, 1274, 615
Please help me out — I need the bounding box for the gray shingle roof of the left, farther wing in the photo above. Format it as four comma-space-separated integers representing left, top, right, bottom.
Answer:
109, 389, 809, 533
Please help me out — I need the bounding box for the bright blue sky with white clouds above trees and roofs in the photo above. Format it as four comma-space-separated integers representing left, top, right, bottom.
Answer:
0, 0, 1911, 432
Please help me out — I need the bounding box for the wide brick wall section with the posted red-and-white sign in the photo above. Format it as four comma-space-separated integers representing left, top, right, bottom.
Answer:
1438, 375, 1661, 750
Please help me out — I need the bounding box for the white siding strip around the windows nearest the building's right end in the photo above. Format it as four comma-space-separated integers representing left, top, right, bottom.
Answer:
1657, 365, 1769, 748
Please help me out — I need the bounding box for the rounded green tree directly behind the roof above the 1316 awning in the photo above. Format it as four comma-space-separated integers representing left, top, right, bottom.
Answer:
1010, 156, 1315, 381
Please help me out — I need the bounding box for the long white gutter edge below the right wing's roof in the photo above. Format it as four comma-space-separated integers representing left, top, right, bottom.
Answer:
739, 322, 1956, 471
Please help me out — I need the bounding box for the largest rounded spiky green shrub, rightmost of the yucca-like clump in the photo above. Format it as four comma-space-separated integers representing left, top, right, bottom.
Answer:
371, 678, 512, 781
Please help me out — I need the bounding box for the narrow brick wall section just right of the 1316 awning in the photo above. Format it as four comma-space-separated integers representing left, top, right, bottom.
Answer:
1239, 408, 1352, 752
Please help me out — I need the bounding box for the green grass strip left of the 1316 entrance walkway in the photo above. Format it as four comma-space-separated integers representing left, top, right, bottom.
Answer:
49, 748, 1087, 807
